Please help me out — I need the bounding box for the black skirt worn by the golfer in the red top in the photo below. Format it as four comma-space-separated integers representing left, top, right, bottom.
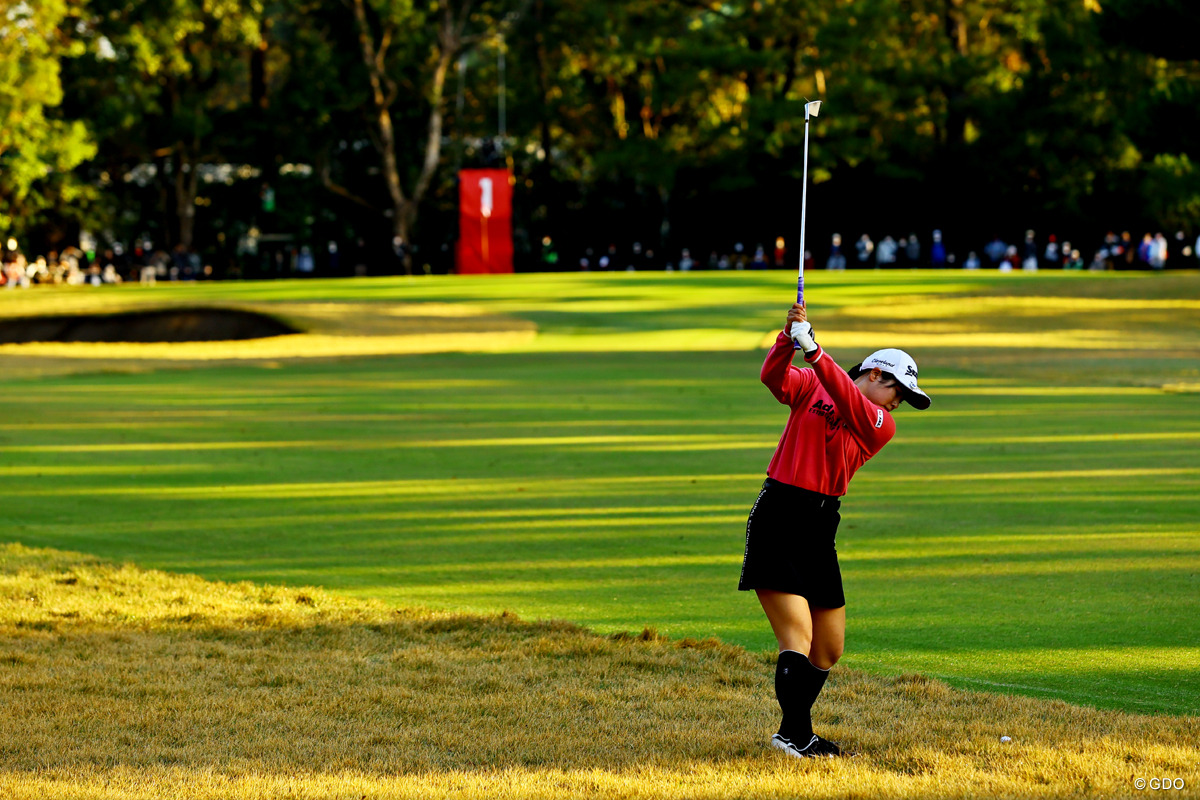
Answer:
738, 477, 846, 608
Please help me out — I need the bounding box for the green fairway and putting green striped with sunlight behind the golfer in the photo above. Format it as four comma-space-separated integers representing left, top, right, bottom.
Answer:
0, 272, 1200, 714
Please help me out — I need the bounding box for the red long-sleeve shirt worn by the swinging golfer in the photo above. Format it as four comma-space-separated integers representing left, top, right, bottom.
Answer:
762, 331, 896, 497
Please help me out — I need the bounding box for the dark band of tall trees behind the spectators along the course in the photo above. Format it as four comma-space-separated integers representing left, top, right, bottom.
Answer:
0, 0, 1200, 276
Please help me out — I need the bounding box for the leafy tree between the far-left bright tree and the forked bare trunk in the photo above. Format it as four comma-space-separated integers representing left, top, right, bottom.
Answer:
72, 0, 269, 247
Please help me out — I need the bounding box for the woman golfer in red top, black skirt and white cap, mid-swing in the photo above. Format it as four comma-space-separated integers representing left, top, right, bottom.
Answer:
738, 303, 930, 758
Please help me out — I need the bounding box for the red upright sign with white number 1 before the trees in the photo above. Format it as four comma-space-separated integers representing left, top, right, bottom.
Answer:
456, 169, 512, 275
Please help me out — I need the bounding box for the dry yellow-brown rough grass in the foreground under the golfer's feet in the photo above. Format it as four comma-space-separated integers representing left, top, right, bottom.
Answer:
0, 545, 1200, 799
